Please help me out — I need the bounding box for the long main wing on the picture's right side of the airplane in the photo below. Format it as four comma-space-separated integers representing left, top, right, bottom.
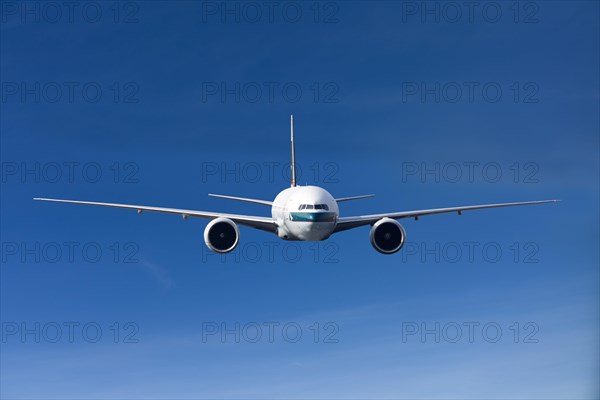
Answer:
333, 200, 560, 233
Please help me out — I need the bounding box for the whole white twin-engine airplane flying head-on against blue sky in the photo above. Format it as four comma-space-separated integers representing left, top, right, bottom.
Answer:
34, 115, 560, 254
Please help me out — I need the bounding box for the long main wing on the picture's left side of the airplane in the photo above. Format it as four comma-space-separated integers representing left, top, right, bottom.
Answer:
34, 197, 277, 233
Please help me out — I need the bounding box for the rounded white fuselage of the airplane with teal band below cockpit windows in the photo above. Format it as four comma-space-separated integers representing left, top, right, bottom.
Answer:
271, 186, 339, 241
